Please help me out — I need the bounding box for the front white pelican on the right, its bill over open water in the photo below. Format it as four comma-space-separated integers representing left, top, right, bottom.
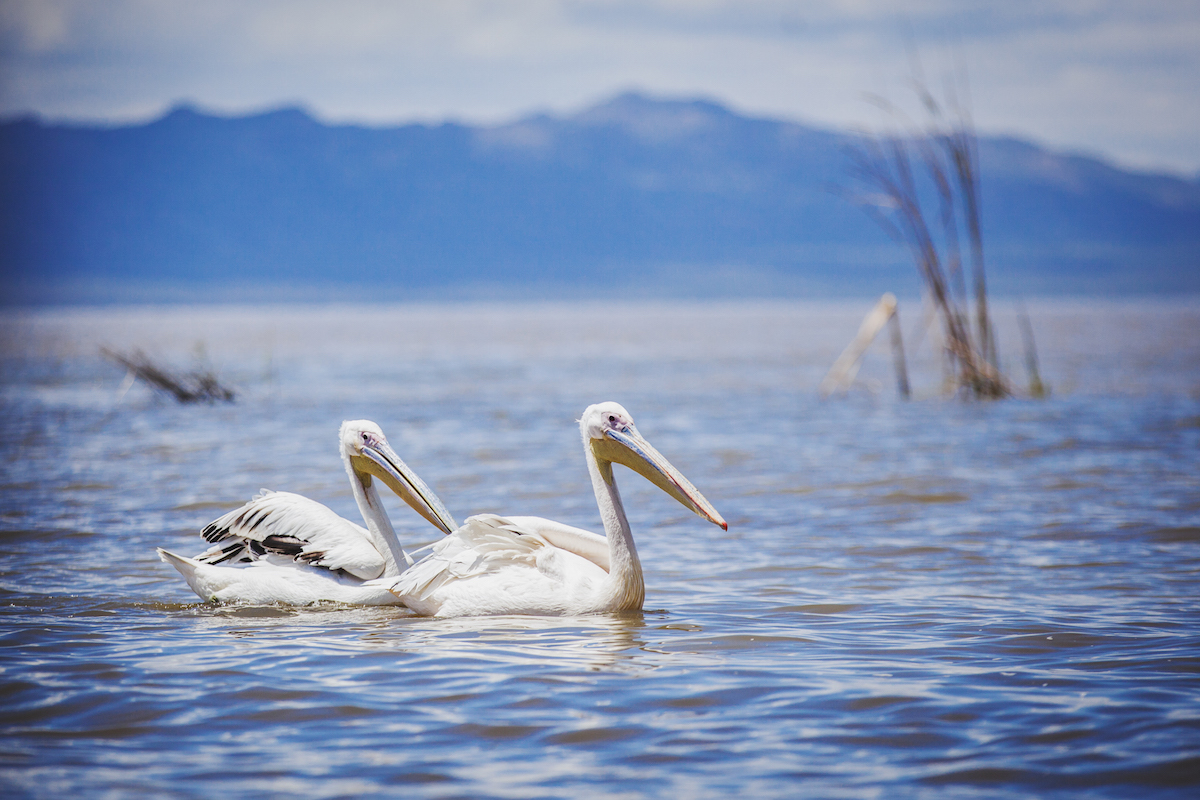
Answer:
391, 403, 728, 616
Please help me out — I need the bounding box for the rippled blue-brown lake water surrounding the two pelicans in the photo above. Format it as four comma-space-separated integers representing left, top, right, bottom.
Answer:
0, 299, 1200, 799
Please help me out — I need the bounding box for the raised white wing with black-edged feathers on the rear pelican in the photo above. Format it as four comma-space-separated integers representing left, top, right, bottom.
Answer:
199, 489, 385, 581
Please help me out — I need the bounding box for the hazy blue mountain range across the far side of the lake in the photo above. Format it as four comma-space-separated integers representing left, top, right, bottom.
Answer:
0, 95, 1200, 302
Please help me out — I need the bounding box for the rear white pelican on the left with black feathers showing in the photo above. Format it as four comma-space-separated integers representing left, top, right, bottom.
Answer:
158, 420, 457, 606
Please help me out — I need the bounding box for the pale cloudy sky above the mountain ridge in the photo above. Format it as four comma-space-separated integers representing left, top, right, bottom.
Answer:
0, 0, 1200, 176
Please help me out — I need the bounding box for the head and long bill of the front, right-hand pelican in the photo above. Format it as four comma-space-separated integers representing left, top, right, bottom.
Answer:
580, 402, 730, 530
